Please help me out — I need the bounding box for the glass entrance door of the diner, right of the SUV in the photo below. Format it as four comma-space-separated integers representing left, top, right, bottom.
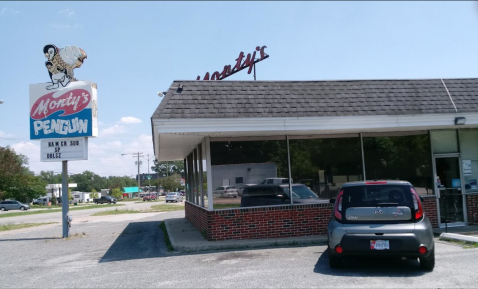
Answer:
435, 156, 465, 227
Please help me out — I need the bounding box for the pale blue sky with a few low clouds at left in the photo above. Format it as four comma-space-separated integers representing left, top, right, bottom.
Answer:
0, 1, 478, 177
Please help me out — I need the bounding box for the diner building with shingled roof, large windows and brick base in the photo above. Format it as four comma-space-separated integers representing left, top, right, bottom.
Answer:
151, 78, 478, 240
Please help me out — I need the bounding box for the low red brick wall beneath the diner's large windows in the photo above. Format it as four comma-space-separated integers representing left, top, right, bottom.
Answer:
185, 196, 440, 241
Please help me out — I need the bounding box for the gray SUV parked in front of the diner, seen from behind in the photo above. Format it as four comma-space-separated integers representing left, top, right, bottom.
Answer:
327, 181, 435, 271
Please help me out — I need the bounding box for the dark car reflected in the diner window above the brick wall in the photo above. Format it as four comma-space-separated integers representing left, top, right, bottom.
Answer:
241, 184, 329, 207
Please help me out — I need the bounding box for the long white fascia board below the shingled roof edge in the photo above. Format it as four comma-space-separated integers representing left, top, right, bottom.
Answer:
153, 113, 478, 134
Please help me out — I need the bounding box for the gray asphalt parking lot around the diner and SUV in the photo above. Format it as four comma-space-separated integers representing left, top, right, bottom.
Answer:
0, 202, 478, 288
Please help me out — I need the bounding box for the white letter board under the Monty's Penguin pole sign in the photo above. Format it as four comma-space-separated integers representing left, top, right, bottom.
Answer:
40, 137, 88, 162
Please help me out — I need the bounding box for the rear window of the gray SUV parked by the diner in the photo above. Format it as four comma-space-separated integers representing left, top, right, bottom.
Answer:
342, 185, 414, 222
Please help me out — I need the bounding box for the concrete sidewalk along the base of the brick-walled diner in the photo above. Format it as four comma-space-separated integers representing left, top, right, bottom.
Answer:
164, 218, 478, 252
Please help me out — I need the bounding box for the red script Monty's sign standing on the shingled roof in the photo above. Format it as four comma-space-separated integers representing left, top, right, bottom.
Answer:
196, 45, 269, 80
